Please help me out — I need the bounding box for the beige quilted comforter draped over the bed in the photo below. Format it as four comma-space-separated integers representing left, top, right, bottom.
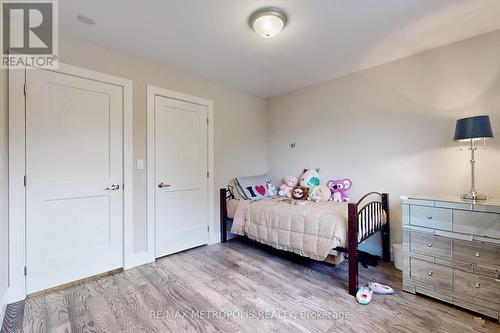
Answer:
231, 198, 347, 260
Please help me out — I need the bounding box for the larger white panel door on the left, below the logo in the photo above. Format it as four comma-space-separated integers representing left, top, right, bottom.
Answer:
26, 69, 123, 293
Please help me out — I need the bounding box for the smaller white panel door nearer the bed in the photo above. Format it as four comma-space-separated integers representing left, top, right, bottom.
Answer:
154, 95, 208, 258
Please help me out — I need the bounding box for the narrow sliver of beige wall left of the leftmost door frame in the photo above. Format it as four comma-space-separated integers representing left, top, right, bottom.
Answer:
0, 69, 9, 312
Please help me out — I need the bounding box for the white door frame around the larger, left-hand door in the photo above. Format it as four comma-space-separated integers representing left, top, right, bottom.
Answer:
9, 63, 137, 303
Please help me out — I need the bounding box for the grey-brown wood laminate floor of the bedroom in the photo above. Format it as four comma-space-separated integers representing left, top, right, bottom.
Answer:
2, 240, 500, 333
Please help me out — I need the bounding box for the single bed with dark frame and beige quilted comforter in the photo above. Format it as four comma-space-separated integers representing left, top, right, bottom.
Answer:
220, 189, 390, 296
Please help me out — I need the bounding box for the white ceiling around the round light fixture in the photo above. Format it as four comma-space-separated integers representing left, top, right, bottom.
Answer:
59, 0, 500, 97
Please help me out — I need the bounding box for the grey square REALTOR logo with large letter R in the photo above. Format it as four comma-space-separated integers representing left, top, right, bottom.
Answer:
0, 0, 57, 69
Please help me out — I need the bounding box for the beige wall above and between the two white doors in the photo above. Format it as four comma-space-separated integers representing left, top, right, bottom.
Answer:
59, 38, 267, 252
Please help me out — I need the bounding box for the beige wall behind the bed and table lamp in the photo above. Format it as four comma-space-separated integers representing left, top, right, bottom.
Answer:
268, 32, 500, 242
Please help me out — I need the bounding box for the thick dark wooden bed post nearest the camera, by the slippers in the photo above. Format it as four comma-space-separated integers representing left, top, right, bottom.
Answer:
347, 203, 358, 296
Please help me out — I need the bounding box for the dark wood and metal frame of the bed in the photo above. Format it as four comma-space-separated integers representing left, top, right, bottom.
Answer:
220, 188, 390, 296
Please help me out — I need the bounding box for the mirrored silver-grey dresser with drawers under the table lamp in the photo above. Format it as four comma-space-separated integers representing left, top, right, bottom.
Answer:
401, 195, 500, 320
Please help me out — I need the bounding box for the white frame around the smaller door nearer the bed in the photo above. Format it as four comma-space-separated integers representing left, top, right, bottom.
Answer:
147, 84, 214, 260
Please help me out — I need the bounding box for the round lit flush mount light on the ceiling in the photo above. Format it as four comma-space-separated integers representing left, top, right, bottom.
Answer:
249, 7, 287, 38
